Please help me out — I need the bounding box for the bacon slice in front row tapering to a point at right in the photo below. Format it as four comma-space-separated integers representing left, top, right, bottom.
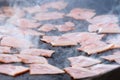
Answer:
30, 64, 64, 75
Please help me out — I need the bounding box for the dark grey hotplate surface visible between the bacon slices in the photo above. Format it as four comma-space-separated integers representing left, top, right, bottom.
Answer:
0, 0, 120, 80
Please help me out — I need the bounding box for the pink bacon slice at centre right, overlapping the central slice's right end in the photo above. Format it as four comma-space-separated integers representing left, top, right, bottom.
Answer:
62, 32, 105, 44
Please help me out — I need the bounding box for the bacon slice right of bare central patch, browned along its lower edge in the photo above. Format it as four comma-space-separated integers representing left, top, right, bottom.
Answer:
78, 41, 113, 55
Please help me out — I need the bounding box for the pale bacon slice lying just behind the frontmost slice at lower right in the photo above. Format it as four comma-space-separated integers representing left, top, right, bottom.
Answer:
68, 56, 101, 67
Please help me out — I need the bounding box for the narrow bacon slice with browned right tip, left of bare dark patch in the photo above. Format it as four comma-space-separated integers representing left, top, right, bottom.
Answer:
20, 48, 55, 57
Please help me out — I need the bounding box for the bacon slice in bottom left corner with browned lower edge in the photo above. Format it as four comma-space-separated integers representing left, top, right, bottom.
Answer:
0, 64, 29, 76
